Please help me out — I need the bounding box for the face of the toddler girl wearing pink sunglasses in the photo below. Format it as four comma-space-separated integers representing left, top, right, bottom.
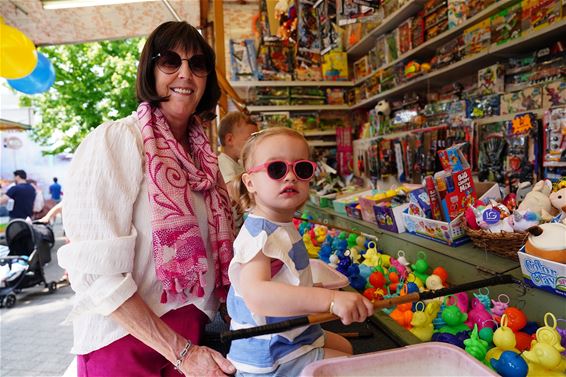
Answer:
242, 134, 309, 222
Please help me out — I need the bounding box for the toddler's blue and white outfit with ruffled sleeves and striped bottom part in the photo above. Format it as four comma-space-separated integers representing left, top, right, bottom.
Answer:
227, 215, 324, 373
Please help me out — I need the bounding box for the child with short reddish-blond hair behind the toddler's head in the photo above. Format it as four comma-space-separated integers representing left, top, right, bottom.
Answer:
218, 111, 258, 186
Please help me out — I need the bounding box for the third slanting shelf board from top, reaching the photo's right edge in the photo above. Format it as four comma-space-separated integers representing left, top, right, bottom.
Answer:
351, 19, 566, 109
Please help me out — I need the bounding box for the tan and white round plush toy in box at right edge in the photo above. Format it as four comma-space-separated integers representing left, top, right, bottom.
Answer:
525, 223, 566, 263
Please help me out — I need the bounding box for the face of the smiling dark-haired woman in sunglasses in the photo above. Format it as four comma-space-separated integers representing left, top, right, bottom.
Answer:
154, 48, 206, 121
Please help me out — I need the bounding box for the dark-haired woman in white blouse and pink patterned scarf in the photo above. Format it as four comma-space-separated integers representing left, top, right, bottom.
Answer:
59, 22, 239, 376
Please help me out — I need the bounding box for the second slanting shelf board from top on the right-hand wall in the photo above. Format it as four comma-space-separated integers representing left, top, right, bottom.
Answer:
355, 0, 516, 85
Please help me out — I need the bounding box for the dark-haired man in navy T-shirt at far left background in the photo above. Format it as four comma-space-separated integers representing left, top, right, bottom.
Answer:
0, 170, 36, 220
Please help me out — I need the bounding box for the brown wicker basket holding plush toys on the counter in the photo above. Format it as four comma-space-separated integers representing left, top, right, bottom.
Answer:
462, 221, 529, 261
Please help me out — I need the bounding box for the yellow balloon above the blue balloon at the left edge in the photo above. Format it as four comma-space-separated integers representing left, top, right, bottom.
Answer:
0, 23, 37, 79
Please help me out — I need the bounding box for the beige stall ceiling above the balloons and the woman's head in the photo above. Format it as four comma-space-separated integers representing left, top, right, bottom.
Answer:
0, 0, 200, 46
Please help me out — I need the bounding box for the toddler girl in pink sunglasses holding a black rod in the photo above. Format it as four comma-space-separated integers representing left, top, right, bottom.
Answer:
228, 127, 373, 377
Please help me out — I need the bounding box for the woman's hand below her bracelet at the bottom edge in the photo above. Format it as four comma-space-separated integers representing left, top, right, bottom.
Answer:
181, 344, 236, 377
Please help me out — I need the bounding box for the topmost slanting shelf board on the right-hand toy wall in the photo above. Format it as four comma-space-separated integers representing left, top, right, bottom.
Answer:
347, 0, 426, 59
